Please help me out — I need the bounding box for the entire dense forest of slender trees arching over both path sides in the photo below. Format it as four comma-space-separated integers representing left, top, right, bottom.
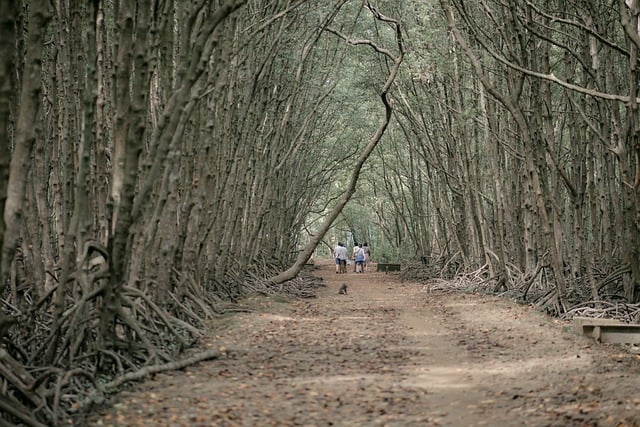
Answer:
0, 0, 640, 426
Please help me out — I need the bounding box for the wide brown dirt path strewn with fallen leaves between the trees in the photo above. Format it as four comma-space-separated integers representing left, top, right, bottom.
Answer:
89, 263, 640, 427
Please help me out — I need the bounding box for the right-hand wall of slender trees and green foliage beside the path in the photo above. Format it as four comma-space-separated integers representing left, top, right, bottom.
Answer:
362, 0, 640, 313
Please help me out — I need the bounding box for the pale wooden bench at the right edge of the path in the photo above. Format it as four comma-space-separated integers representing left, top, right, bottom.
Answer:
573, 317, 640, 344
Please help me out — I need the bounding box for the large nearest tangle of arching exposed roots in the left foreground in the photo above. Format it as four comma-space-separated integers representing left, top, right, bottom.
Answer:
0, 281, 217, 426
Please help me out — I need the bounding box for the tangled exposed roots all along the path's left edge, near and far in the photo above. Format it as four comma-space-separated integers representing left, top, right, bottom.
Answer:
0, 260, 330, 427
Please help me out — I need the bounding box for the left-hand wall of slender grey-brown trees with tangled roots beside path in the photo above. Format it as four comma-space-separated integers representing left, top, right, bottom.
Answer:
0, 0, 400, 425
